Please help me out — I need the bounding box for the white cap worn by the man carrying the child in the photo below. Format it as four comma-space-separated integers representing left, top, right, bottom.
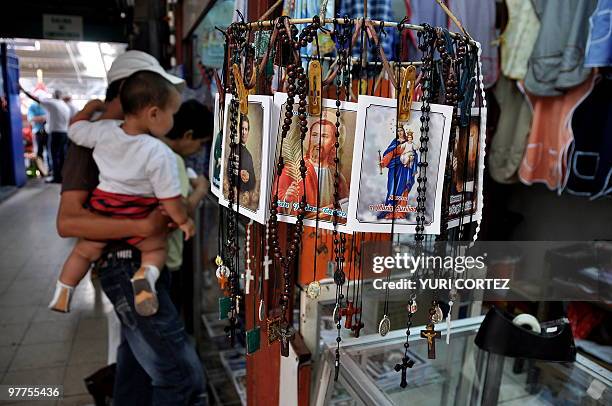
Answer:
106, 51, 185, 91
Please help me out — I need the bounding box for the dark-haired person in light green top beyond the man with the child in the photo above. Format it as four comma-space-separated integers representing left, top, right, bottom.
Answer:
161, 100, 213, 314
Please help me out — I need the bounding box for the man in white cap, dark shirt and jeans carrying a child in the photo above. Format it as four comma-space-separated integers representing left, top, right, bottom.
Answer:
57, 51, 208, 406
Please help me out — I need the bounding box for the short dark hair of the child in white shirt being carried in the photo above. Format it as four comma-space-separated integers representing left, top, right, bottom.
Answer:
119, 71, 174, 114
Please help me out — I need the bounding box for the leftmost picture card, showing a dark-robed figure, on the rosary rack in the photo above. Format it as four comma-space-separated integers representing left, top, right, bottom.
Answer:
219, 94, 272, 224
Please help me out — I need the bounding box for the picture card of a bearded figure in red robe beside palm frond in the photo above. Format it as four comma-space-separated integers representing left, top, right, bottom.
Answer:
270, 93, 357, 232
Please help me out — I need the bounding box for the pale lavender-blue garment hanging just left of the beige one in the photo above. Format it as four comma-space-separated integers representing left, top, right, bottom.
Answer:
448, 0, 499, 88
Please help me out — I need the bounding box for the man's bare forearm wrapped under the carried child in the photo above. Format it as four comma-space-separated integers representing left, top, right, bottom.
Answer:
57, 190, 169, 240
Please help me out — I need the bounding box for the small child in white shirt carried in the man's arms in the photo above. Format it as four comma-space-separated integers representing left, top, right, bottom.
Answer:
49, 71, 195, 316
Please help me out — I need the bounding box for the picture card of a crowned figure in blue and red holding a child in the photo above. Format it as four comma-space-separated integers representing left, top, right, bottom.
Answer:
348, 96, 453, 234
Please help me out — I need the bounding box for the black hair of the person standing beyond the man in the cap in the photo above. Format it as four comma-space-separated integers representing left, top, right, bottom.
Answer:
166, 99, 213, 140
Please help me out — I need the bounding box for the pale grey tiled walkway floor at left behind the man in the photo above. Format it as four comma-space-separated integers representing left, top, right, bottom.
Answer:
0, 182, 112, 405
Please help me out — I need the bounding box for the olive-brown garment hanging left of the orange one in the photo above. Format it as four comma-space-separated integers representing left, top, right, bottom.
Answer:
488, 75, 532, 183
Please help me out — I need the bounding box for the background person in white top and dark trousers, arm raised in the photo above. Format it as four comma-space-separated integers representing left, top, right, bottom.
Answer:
19, 89, 70, 183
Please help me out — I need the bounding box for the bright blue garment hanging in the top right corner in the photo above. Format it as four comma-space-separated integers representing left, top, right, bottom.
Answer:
584, 0, 612, 68
